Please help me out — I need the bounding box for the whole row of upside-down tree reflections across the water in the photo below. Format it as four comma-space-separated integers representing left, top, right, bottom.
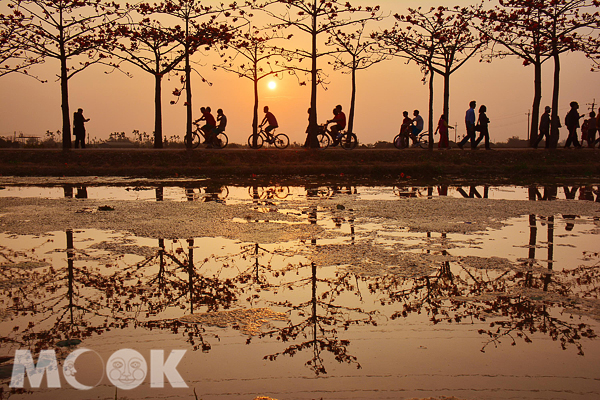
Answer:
0, 205, 600, 382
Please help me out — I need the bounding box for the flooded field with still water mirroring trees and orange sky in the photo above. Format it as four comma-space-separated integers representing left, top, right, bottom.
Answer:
0, 178, 600, 400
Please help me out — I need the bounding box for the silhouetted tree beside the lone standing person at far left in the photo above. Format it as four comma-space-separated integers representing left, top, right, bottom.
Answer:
7, 0, 126, 150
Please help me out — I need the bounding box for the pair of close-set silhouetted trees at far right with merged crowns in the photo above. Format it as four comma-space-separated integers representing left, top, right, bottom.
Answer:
474, 0, 600, 147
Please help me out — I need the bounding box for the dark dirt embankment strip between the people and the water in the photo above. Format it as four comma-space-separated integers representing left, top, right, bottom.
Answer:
0, 149, 600, 181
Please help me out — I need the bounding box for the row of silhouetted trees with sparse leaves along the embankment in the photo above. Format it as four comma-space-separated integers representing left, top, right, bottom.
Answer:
0, 0, 600, 149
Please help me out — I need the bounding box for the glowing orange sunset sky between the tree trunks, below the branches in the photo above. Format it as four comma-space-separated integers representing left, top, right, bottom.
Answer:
0, 0, 600, 147
